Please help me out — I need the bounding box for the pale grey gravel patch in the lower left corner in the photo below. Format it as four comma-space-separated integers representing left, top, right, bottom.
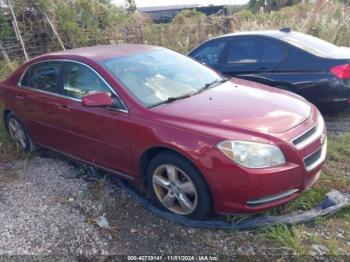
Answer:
0, 157, 115, 255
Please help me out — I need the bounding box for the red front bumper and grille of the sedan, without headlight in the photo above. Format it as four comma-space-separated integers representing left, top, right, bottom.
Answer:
206, 108, 327, 214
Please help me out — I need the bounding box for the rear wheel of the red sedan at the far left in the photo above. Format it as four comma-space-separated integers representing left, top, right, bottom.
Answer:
5, 112, 36, 152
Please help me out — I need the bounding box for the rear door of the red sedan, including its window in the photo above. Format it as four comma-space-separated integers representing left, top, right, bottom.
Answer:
15, 61, 74, 151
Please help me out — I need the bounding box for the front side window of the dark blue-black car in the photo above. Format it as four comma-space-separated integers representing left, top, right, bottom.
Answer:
192, 41, 225, 65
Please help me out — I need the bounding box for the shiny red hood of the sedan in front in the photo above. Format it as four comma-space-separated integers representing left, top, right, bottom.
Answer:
153, 79, 311, 133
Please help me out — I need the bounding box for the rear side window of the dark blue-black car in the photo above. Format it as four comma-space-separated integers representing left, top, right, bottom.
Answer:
225, 39, 260, 65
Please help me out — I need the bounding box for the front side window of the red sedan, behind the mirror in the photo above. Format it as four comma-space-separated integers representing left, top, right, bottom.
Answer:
63, 62, 112, 99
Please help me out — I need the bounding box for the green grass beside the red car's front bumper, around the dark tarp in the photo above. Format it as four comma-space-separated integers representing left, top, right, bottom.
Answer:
259, 129, 350, 256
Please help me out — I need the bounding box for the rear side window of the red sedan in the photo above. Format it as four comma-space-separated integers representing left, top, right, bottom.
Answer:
21, 61, 61, 92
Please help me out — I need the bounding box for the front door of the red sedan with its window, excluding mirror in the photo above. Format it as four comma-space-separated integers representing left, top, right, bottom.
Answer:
57, 62, 130, 174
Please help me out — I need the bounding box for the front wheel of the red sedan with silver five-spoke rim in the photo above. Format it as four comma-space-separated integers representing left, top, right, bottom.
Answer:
147, 152, 212, 219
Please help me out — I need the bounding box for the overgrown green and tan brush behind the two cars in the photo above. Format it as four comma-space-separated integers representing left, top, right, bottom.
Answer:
0, 0, 350, 59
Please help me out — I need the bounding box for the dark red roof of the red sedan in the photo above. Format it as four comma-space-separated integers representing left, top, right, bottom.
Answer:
40, 44, 162, 61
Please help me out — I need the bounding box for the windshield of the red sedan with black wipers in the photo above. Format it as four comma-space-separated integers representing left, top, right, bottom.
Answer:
104, 49, 223, 107
